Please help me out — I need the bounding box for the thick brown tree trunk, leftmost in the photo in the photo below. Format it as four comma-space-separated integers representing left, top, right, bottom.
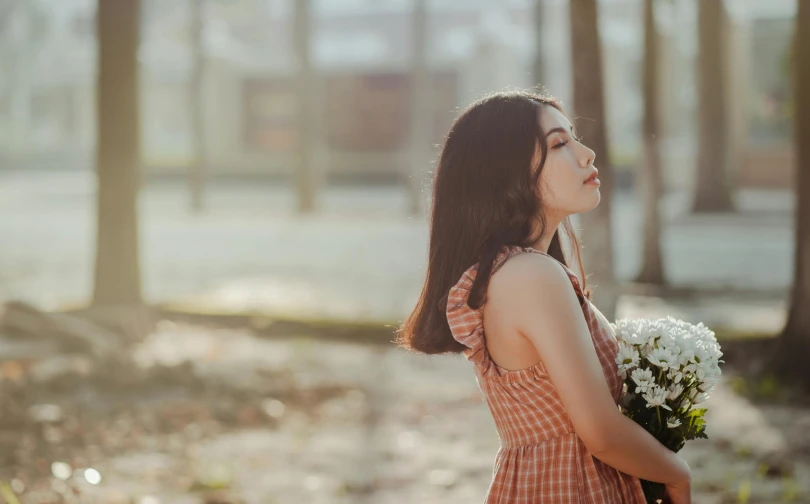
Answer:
93, 0, 141, 306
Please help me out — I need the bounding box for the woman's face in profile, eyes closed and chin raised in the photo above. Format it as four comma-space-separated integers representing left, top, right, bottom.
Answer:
535, 105, 602, 219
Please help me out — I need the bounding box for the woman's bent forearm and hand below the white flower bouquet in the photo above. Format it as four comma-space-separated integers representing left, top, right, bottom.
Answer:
592, 413, 691, 484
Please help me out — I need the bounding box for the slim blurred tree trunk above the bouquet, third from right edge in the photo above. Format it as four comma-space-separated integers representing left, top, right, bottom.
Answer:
636, 0, 665, 285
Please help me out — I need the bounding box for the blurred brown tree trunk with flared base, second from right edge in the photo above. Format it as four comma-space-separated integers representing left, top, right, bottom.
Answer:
692, 0, 734, 213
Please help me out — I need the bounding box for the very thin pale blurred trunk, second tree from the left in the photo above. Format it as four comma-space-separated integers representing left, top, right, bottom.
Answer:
188, 0, 206, 213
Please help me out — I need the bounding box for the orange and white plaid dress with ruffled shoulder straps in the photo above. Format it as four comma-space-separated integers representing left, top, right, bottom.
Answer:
447, 247, 646, 504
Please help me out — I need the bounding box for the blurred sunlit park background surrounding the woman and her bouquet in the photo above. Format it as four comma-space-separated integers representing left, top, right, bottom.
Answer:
0, 0, 810, 504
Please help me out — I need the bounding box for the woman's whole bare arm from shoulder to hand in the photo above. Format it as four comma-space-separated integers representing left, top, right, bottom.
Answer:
487, 254, 690, 484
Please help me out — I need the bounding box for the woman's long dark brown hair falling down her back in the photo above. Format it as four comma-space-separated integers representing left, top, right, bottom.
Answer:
396, 91, 590, 354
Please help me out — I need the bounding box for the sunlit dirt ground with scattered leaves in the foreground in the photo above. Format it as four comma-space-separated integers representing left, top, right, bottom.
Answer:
0, 321, 810, 504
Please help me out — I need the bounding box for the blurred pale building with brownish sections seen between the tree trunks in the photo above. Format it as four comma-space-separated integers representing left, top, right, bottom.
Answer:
0, 0, 795, 191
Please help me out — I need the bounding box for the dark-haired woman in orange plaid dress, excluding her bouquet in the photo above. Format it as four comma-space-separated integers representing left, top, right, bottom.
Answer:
398, 92, 691, 504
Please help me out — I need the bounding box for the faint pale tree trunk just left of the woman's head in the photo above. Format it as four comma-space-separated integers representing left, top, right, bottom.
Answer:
404, 0, 433, 215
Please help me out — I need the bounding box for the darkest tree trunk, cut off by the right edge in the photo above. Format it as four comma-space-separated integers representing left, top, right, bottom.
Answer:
766, 1, 810, 389
